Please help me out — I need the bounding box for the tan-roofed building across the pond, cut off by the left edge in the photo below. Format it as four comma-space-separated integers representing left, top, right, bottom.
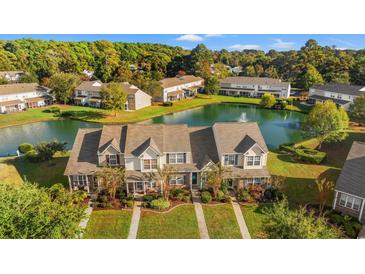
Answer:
0, 83, 53, 113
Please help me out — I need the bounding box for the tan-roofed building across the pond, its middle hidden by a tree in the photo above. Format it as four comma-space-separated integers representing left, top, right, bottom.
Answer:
73, 81, 152, 110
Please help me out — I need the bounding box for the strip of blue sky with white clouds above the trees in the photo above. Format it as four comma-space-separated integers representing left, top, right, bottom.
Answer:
0, 34, 365, 51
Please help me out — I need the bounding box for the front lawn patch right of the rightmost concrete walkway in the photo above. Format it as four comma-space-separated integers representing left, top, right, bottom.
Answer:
241, 204, 270, 239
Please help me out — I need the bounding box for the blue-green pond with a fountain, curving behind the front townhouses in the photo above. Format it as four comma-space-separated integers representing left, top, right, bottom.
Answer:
0, 104, 305, 155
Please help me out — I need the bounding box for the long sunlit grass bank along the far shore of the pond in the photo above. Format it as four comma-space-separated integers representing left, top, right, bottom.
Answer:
0, 94, 305, 128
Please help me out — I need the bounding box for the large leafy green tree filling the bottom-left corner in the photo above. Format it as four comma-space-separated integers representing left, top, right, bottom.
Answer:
0, 183, 85, 239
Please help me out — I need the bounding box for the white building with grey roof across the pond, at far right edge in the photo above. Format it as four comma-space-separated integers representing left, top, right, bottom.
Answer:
308, 84, 365, 110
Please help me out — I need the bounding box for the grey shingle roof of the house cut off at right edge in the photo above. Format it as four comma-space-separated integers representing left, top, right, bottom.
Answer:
336, 142, 365, 198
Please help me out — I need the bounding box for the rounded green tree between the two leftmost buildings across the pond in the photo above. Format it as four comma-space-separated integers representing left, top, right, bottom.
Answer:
48, 72, 78, 104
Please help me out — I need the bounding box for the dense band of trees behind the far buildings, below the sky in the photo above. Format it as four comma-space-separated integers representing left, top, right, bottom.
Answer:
0, 39, 365, 92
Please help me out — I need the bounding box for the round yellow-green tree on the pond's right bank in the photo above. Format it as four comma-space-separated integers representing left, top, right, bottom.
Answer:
303, 100, 349, 148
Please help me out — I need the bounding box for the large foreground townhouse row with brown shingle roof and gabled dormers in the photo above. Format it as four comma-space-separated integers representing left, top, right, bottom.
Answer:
64, 123, 270, 193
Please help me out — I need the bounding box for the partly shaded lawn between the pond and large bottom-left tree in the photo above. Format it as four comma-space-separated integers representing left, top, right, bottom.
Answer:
0, 153, 68, 187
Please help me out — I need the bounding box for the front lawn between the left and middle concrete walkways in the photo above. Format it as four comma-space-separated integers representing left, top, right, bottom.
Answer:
137, 205, 200, 239
